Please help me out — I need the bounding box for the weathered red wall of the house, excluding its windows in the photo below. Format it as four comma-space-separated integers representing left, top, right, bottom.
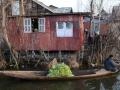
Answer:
8, 15, 84, 51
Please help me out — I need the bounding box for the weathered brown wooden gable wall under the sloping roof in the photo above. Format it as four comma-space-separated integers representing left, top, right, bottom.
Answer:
6, 0, 52, 16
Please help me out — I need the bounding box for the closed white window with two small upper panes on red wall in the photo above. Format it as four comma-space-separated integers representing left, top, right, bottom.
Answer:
56, 22, 73, 37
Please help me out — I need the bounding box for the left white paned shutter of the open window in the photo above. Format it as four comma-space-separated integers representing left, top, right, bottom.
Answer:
24, 18, 31, 33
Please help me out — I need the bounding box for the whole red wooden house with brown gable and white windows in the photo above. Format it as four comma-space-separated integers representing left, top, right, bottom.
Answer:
8, 0, 88, 51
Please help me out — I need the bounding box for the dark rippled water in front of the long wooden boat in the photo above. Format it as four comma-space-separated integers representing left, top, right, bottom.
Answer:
0, 74, 120, 90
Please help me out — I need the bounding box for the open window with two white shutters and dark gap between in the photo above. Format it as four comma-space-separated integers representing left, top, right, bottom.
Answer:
24, 18, 45, 33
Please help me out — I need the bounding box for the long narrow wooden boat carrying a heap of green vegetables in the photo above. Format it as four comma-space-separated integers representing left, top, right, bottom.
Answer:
0, 69, 116, 80
